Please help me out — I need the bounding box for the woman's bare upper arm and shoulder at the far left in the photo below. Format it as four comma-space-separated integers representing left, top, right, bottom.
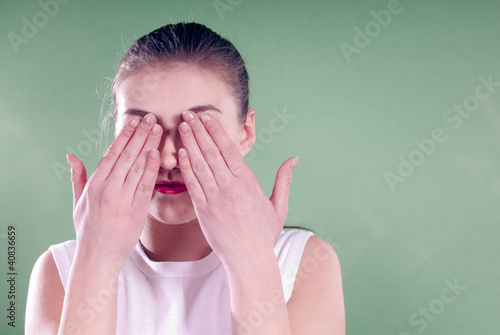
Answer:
25, 250, 64, 334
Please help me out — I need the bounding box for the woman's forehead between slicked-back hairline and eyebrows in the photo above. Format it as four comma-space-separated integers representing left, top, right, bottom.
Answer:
116, 64, 238, 124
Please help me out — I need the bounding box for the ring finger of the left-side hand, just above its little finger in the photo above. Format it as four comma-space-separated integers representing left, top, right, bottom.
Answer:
122, 124, 162, 196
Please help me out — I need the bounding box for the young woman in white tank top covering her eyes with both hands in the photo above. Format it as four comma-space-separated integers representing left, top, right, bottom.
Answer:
25, 23, 345, 335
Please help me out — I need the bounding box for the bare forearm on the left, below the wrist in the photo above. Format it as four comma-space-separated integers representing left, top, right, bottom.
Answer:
58, 251, 121, 335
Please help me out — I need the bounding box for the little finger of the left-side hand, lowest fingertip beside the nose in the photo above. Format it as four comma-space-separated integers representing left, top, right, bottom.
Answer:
132, 148, 160, 208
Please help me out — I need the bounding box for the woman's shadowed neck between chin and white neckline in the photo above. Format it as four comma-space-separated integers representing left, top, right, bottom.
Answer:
140, 216, 212, 262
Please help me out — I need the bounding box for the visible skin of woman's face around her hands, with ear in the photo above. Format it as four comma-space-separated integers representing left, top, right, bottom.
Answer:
115, 64, 255, 224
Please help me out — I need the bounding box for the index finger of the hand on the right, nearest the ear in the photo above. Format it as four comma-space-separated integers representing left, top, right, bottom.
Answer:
197, 113, 251, 177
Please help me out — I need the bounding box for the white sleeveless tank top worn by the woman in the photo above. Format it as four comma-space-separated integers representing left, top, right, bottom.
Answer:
49, 229, 313, 335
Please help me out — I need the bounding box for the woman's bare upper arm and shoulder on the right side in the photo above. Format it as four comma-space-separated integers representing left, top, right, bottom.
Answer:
287, 235, 345, 335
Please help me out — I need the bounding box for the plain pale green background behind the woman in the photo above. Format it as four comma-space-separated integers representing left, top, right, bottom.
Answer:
0, 0, 500, 335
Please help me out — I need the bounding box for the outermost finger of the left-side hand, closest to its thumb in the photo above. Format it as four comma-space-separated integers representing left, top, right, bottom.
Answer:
91, 117, 140, 182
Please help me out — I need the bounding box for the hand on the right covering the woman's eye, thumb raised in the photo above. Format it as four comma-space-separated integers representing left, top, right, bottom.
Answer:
178, 111, 297, 263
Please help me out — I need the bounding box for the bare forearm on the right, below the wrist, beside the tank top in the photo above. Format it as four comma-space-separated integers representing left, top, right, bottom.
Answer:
227, 250, 291, 335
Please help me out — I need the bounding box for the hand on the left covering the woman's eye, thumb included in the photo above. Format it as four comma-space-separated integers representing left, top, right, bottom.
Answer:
68, 114, 162, 269
